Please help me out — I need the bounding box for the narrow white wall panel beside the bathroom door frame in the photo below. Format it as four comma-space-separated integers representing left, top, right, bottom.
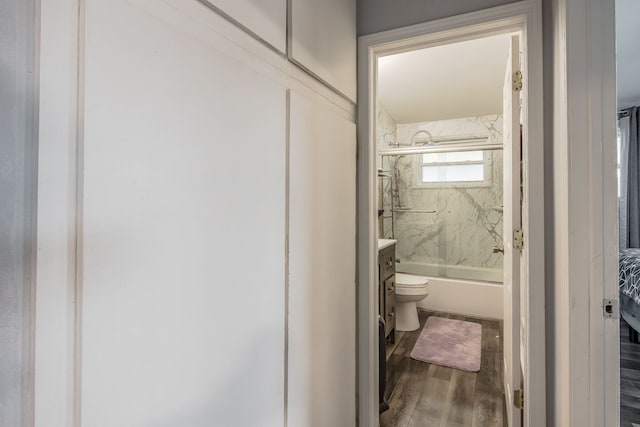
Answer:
287, 92, 356, 427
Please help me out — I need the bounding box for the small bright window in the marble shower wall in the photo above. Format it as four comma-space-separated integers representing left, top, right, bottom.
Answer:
418, 151, 490, 185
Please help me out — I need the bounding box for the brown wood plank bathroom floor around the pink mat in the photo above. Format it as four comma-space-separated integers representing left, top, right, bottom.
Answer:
380, 311, 507, 427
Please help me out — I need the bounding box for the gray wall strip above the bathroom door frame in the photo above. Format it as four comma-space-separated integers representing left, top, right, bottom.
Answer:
357, 0, 515, 36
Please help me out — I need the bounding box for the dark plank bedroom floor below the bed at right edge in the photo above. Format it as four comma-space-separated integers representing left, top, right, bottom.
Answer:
620, 320, 640, 427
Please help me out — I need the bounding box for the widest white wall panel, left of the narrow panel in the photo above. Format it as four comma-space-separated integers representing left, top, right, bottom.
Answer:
81, 0, 286, 427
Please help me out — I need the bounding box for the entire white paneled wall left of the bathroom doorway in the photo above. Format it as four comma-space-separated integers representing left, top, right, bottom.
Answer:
34, 0, 356, 427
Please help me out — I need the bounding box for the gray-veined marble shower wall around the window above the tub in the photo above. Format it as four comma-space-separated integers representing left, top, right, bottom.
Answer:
378, 115, 503, 275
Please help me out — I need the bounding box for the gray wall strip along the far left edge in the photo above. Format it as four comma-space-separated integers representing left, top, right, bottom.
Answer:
0, 0, 36, 427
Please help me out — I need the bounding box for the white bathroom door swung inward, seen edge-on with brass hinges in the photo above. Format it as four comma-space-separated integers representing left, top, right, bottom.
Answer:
503, 36, 525, 427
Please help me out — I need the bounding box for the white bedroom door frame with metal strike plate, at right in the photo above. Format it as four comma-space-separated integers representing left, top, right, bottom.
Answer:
545, 0, 620, 427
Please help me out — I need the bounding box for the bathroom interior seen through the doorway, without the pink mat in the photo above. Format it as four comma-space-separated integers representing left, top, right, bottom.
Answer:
376, 34, 511, 427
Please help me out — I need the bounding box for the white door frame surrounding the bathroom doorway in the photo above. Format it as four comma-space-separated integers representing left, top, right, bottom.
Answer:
357, 0, 546, 427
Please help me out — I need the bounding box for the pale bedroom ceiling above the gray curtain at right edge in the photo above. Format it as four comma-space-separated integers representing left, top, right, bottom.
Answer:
616, 0, 640, 108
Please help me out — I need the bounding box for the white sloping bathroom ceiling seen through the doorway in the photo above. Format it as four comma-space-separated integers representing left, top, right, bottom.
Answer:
378, 35, 510, 123
